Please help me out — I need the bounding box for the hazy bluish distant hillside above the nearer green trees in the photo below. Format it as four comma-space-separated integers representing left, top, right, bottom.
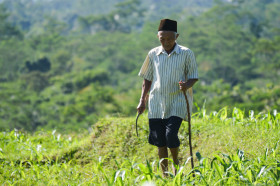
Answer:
0, 0, 213, 35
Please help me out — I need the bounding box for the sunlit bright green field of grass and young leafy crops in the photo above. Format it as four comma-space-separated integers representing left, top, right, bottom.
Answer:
0, 108, 280, 185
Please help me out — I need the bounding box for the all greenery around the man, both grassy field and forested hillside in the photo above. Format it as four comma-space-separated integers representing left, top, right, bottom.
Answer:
0, 0, 280, 185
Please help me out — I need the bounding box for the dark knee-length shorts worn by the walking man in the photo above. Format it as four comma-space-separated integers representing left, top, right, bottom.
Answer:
149, 116, 183, 148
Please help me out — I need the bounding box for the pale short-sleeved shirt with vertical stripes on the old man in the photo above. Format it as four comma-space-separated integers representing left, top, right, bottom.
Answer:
138, 43, 198, 120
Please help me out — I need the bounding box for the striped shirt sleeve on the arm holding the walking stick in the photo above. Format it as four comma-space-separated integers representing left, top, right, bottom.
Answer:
185, 50, 198, 79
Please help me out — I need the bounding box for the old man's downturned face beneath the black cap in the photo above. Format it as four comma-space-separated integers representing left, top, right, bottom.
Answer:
158, 31, 179, 52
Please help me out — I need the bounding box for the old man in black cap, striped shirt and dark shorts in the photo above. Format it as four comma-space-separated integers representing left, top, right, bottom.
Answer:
137, 19, 198, 176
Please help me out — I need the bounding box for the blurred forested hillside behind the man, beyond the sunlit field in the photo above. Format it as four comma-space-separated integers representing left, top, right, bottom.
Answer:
0, 0, 280, 132
